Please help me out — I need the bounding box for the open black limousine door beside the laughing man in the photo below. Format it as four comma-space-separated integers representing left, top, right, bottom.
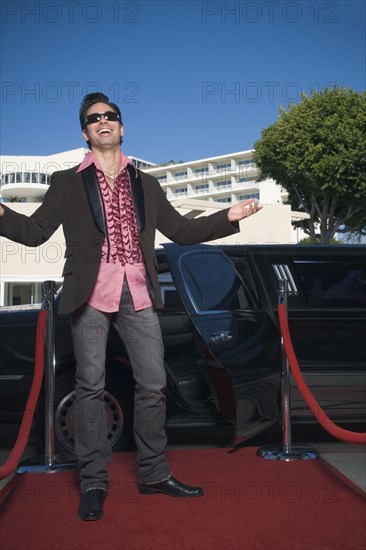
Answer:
164, 243, 280, 437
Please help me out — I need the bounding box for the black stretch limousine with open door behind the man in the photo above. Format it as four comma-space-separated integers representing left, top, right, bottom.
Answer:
0, 244, 366, 452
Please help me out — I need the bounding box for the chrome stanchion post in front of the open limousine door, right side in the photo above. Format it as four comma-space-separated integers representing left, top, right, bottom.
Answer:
257, 279, 319, 461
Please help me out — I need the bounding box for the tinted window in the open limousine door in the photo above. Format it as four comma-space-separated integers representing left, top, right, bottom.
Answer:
179, 250, 247, 311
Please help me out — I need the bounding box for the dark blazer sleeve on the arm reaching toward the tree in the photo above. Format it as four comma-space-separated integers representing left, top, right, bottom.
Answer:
154, 178, 240, 245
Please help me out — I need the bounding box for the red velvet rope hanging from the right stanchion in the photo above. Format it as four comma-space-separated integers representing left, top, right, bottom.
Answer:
278, 304, 366, 445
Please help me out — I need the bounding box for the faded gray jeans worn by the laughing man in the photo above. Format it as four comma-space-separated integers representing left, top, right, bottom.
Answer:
71, 282, 170, 492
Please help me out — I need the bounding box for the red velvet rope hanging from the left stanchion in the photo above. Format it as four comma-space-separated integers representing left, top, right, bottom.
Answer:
0, 309, 48, 479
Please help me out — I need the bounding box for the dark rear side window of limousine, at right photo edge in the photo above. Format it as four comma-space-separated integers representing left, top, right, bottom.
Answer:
293, 258, 366, 308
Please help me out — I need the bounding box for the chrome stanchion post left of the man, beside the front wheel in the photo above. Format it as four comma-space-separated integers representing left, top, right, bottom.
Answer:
16, 281, 77, 474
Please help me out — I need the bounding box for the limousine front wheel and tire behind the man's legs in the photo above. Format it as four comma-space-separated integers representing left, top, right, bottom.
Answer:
37, 365, 134, 454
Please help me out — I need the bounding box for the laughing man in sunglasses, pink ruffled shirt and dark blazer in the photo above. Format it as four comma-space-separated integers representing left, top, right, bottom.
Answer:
0, 93, 260, 521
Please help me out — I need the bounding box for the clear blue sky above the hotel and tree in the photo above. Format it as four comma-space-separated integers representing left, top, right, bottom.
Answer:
0, 0, 366, 163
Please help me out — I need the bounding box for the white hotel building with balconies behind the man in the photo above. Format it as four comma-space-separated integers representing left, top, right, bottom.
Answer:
0, 148, 306, 306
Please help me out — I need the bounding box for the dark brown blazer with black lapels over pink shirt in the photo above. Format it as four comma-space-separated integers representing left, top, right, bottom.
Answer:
0, 165, 239, 314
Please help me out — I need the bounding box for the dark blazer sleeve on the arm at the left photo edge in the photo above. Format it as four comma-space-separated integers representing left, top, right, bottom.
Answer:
0, 174, 62, 246
